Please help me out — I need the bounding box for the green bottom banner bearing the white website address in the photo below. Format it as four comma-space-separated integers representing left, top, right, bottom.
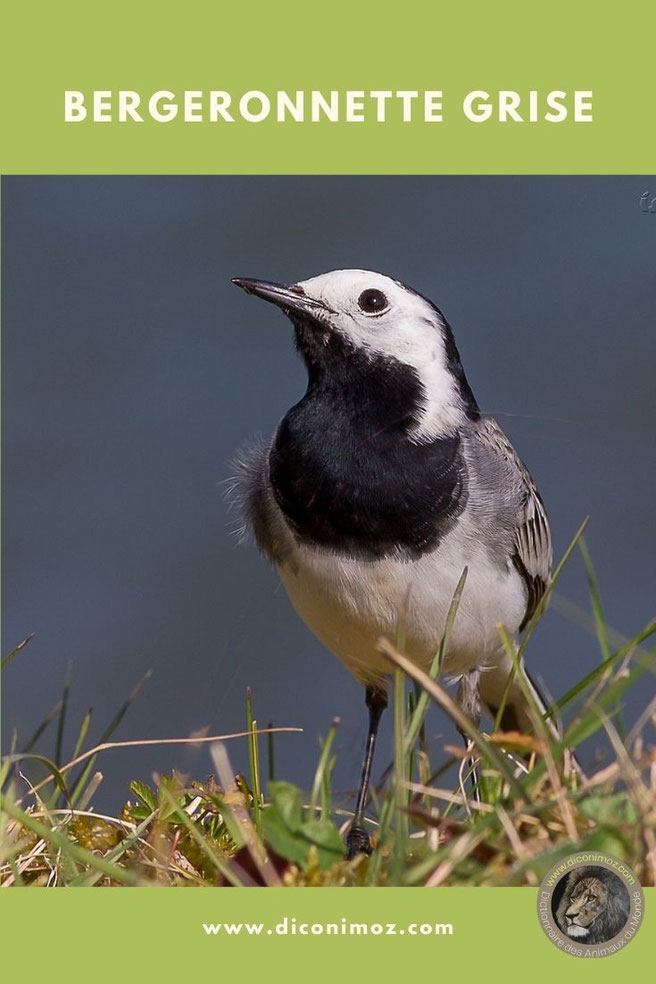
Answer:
2, 888, 656, 984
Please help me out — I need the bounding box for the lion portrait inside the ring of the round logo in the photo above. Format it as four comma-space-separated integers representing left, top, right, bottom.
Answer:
556, 866, 631, 943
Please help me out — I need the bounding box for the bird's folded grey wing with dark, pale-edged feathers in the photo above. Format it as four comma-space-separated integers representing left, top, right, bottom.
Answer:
476, 418, 553, 631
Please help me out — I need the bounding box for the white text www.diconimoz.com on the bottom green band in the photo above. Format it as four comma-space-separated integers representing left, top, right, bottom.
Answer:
202, 916, 453, 936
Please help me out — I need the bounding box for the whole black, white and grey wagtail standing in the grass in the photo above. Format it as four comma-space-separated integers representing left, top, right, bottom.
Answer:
233, 270, 552, 856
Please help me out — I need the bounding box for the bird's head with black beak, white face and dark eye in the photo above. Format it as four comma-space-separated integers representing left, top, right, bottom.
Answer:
233, 270, 479, 441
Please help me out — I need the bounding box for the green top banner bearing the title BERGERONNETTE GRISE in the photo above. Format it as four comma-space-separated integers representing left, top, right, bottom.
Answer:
1, 0, 656, 174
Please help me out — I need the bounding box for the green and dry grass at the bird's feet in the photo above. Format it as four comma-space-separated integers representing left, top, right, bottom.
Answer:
0, 529, 656, 887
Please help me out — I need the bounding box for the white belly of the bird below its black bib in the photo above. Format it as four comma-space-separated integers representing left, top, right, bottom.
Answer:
280, 527, 526, 685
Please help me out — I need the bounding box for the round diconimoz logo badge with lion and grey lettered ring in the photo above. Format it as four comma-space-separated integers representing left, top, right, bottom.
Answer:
538, 851, 645, 957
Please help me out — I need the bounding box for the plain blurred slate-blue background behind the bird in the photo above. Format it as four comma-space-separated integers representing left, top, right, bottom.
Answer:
2, 177, 656, 808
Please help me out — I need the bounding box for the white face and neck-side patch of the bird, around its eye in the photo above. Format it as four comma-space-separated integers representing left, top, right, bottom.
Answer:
295, 270, 464, 440
